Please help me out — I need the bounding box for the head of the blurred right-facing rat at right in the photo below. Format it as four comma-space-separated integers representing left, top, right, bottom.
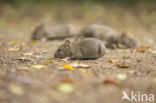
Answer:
120, 32, 136, 48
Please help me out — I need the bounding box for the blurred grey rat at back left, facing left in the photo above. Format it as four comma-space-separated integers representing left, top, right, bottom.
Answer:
31, 24, 78, 40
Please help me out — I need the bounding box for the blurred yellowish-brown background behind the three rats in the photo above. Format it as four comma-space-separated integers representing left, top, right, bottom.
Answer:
0, 0, 156, 44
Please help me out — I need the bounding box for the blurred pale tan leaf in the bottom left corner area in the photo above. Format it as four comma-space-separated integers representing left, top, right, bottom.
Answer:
8, 84, 24, 95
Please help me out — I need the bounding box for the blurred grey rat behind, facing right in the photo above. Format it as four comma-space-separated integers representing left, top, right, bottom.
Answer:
80, 24, 136, 48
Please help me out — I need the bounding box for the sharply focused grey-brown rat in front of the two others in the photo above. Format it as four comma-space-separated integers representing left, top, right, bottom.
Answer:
54, 38, 106, 59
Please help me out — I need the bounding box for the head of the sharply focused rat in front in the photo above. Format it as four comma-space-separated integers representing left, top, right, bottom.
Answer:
54, 40, 71, 58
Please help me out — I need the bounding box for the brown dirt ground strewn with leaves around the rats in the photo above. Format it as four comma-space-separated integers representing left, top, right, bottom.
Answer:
0, 39, 156, 103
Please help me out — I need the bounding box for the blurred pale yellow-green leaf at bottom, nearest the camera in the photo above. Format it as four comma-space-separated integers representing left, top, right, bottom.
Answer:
56, 82, 74, 94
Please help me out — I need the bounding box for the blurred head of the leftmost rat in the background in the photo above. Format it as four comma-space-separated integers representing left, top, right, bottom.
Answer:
32, 25, 47, 40
